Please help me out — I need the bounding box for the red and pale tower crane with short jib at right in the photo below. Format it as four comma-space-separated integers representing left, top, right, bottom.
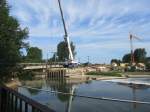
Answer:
129, 33, 141, 65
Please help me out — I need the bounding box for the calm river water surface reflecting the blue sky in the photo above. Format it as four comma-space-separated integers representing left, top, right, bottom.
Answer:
18, 79, 150, 112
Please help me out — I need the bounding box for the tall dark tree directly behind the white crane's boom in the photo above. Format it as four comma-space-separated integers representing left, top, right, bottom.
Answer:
57, 41, 76, 61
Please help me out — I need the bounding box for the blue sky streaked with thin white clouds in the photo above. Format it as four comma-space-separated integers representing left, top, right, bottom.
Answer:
7, 0, 150, 63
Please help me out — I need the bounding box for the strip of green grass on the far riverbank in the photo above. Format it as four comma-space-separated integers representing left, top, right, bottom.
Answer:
86, 72, 121, 77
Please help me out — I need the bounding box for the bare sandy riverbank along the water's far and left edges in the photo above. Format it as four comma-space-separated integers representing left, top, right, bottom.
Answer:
5, 72, 150, 88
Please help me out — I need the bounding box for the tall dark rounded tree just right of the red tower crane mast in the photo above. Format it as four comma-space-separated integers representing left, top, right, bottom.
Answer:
134, 48, 146, 63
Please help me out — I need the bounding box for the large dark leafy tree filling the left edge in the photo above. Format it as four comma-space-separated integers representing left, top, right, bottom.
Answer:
0, 0, 28, 78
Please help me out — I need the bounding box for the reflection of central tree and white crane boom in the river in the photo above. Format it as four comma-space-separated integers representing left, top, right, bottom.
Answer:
46, 78, 81, 112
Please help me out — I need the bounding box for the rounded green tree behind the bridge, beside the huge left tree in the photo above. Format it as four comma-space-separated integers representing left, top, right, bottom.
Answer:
26, 47, 42, 62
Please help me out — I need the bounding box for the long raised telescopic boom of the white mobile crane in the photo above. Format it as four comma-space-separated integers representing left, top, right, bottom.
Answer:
58, 0, 74, 62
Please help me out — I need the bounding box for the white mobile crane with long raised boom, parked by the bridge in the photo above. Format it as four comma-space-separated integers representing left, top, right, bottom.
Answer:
58, 0, 78, 66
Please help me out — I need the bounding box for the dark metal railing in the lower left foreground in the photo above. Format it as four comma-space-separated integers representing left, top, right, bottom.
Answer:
0, 86, 54, 112
